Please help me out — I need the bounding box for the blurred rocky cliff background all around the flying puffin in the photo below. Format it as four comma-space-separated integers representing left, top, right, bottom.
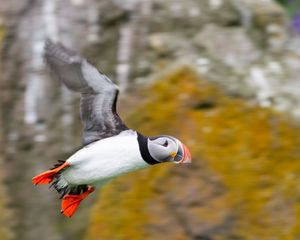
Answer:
0, 0, 300, 240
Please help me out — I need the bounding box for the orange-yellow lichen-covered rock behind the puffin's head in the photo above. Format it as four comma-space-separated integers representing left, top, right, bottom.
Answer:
86, 67, 300, 240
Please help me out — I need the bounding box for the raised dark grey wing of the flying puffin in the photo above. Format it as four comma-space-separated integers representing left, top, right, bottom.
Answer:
44, 39, 128, 145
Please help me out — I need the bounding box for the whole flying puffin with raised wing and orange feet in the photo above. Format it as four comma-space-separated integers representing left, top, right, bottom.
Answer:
32, 39, 192, 217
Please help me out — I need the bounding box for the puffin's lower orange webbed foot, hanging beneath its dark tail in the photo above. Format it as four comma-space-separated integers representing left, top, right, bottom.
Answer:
61, 186, 95, 217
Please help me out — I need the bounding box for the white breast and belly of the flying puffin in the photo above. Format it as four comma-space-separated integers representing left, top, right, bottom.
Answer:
61, 130, 149, 185
